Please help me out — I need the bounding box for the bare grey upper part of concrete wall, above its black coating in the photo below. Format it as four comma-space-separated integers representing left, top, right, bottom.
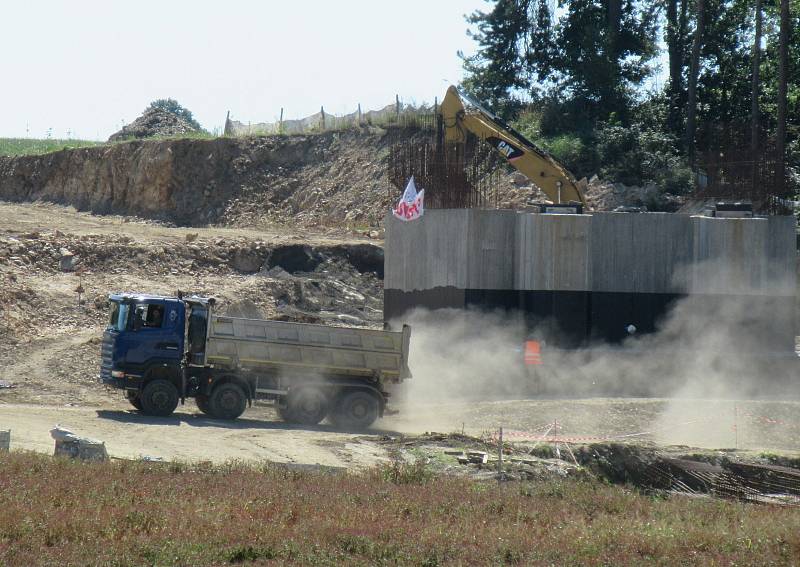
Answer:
384, 209, 797, 297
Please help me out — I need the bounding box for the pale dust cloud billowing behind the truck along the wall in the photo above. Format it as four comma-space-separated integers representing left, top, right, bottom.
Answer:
390, 265, 800, 447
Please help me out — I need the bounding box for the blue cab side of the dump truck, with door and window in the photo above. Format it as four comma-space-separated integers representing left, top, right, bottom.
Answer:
120, 301, 183, 374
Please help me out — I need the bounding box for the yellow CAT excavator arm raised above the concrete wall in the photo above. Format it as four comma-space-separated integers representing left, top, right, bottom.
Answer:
439, 86, 586, 206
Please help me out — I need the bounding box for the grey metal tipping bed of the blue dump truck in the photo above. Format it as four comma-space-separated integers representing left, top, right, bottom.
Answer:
206, 315, 411, 382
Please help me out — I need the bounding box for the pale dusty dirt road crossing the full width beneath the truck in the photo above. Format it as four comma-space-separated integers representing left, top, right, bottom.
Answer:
0, 394, 800, 469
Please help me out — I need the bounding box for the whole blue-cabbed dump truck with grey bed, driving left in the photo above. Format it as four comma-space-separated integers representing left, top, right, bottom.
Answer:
100, 294, 411, 429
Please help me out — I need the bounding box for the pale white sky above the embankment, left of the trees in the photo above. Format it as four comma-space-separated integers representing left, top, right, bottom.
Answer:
0, 0, 490, 139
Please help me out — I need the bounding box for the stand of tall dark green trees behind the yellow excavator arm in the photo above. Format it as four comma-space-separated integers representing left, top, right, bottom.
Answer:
462, 0, 800, 200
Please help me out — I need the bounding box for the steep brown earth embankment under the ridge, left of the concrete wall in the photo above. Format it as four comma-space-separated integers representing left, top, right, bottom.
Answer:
0, 130, 398, 226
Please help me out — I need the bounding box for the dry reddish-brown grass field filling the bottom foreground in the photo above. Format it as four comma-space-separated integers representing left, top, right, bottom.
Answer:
0, 453, 800, 566
